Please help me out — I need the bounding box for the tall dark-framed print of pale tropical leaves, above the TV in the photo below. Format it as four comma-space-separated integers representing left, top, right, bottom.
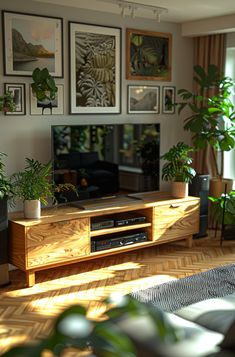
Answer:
69, 22, 121, 114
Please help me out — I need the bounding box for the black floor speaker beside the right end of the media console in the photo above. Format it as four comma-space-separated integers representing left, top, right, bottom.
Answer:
189, 175, 210, 238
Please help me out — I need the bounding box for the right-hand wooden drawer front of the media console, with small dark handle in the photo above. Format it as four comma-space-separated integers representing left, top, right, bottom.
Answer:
153, 200, 199, 241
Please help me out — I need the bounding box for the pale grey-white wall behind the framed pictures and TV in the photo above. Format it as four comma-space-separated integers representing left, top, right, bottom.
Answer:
0, 0, 193, 199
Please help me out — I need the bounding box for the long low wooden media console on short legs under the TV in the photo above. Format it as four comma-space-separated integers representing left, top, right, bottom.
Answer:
9, 192, 200, 286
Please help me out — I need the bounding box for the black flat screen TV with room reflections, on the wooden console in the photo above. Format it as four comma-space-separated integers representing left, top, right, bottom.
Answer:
51, 124, 160, 202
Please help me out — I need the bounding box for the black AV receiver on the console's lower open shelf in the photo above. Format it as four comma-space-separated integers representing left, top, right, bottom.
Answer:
91, 232, 148, 252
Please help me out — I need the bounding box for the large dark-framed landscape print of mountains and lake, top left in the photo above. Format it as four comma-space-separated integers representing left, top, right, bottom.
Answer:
2, 11, 63, 77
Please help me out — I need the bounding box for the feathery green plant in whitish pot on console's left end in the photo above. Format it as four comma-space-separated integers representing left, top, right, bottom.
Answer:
11, 158, 76, 218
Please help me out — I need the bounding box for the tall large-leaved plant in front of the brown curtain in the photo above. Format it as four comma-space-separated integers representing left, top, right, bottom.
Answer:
178, 64, 235, 177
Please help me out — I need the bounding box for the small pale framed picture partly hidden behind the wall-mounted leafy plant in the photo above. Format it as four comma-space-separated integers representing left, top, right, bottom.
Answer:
30, 84, 64, 115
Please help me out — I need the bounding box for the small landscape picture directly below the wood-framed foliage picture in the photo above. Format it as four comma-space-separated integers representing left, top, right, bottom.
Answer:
127, 85, 159, 114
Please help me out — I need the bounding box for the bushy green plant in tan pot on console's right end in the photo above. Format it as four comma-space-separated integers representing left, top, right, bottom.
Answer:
161, 142, 196, 198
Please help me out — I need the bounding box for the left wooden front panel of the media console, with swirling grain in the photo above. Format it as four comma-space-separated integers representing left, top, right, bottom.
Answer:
26, 218, 90, 269
